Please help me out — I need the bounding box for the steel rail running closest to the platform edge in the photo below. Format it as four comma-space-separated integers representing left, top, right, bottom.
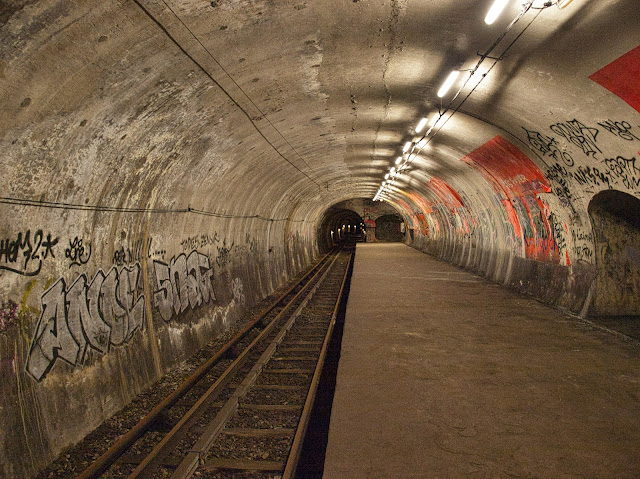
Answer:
282, 250, 355, 479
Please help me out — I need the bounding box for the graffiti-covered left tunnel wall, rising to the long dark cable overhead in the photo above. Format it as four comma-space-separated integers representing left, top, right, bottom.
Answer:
0, 2, 319, 477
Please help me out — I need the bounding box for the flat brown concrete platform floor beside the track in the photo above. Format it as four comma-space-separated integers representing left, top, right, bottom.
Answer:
324, 244, 640, 479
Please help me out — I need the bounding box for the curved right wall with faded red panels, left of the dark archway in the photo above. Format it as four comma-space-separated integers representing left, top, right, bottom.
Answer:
398, 124, 635, 313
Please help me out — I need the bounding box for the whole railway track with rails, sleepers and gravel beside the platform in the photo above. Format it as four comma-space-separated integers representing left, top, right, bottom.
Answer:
78, 248, 353, 479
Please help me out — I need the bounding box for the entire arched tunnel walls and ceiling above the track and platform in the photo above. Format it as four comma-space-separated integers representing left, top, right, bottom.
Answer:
0, 0, 640, 478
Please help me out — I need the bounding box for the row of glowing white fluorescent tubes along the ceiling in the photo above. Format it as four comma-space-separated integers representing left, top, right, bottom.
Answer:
373, 0, 556, 201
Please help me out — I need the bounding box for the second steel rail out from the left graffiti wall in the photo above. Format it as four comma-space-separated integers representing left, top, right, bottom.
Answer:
128, 255, 337, 479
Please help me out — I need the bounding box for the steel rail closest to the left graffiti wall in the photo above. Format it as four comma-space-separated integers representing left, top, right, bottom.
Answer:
77, 251, 334, 479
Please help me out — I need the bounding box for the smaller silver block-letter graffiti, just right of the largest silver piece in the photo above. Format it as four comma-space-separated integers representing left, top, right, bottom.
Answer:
153, 250, 216, 321
